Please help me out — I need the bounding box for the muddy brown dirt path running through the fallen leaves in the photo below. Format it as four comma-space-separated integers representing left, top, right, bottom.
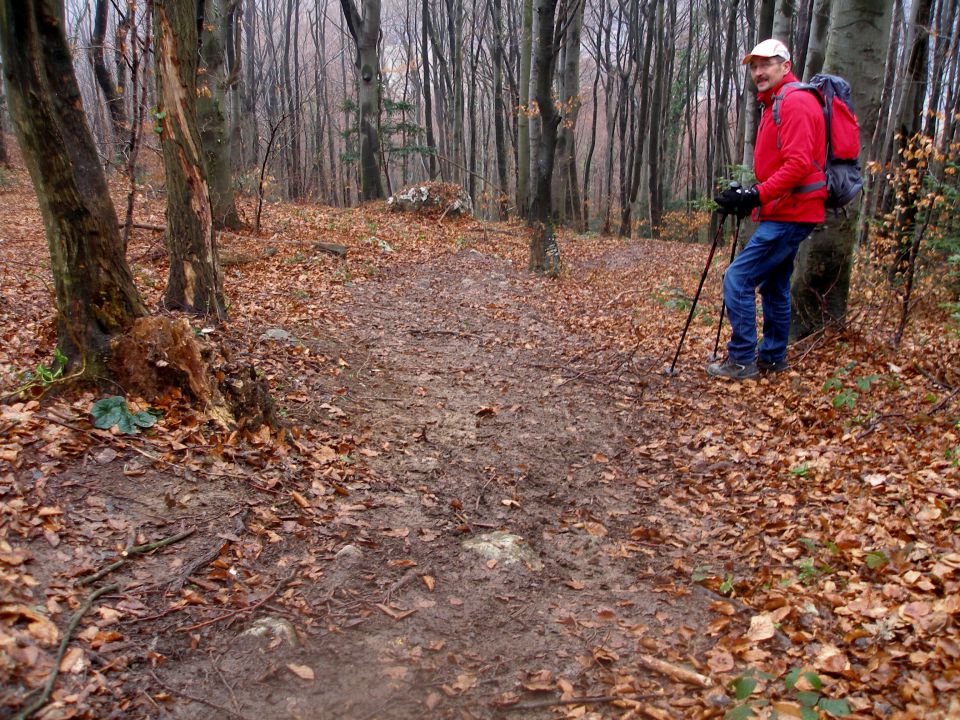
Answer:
161, 245, 724, 718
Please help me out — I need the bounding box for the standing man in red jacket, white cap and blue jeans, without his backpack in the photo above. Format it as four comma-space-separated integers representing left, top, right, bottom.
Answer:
707, 39, 827, 380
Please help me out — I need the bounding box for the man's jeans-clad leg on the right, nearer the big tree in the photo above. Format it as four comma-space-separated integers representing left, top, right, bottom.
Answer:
759, 223, 815, 366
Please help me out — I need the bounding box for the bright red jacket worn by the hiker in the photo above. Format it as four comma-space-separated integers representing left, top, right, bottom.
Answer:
753, 73, 827, 223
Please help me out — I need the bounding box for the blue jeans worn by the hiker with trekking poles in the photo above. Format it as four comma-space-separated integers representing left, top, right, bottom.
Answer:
723, 221, 815, 365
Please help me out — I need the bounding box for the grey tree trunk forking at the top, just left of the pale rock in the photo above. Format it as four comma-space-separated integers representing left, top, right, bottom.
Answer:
340, 0, 384, 200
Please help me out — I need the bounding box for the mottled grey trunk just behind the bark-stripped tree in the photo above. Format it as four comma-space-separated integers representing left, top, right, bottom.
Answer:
197, 0, 241, 229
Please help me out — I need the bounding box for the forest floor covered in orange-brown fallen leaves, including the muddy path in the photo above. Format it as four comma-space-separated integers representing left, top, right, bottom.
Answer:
0, 158, 960, 720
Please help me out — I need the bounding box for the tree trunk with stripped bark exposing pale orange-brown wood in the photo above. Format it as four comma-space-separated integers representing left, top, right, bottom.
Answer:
153, 0, 226, 320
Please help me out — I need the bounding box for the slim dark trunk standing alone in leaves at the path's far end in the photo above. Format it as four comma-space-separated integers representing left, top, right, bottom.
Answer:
529, 0, 560, 276
